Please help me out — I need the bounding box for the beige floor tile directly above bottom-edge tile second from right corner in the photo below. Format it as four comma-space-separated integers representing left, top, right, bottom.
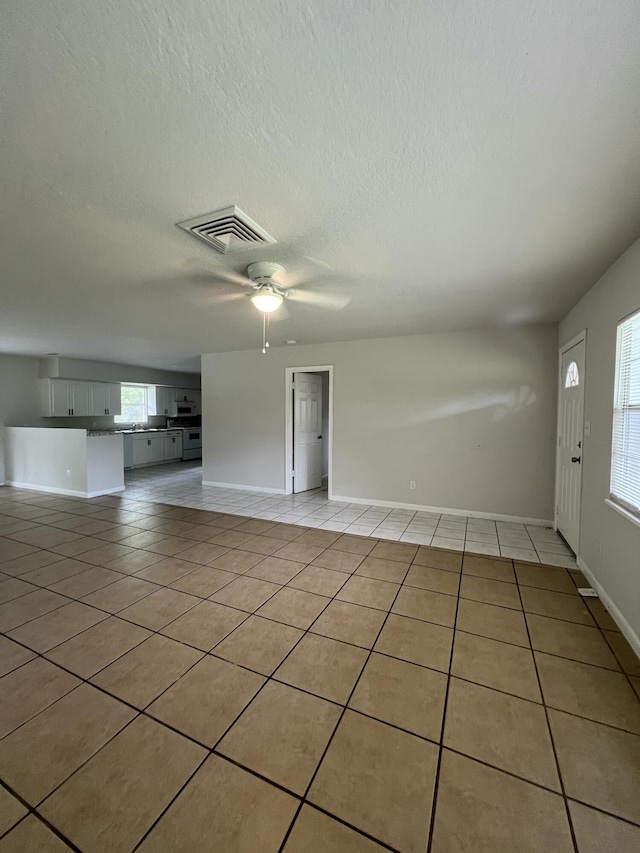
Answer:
443, 678, 560, 791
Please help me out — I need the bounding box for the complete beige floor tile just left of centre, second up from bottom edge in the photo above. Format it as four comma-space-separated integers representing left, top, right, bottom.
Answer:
218, 681, 341, 794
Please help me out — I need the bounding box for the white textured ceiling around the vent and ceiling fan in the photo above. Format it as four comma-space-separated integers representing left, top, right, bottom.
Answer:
0, 0, 640, 369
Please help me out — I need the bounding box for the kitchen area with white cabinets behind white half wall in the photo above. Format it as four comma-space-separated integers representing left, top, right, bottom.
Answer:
4, 378, 202, 497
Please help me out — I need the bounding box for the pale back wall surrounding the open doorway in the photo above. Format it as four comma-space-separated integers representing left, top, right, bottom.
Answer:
202, 326, 557, 519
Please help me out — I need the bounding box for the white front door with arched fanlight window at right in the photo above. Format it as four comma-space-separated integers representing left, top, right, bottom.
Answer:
556, 340, 585, 553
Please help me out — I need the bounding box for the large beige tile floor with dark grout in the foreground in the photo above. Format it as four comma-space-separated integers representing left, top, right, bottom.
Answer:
0, 474, 640, 853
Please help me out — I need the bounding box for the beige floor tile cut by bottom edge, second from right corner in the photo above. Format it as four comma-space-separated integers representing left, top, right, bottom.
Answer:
431, 749, 574, 853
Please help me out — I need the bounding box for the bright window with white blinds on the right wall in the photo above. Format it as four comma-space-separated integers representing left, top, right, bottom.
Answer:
611, 311, 640, 515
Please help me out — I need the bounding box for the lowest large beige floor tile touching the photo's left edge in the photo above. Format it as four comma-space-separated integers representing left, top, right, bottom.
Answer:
0, 684, 136, 805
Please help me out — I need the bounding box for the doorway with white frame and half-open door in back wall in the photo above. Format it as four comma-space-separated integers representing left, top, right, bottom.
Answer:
285, 365, 333, 498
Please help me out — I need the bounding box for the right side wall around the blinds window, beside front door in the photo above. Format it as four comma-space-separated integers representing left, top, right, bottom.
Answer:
559, 240, 640, 637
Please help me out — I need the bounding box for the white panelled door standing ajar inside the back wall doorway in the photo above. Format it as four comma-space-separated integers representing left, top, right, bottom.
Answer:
293, 373, 323, 493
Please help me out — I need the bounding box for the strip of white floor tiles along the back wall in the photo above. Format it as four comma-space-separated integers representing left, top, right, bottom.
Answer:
125, 462, 576, 568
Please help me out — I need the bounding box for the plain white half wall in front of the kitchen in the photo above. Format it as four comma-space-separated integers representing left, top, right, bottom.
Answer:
4, 427, 124, 498
